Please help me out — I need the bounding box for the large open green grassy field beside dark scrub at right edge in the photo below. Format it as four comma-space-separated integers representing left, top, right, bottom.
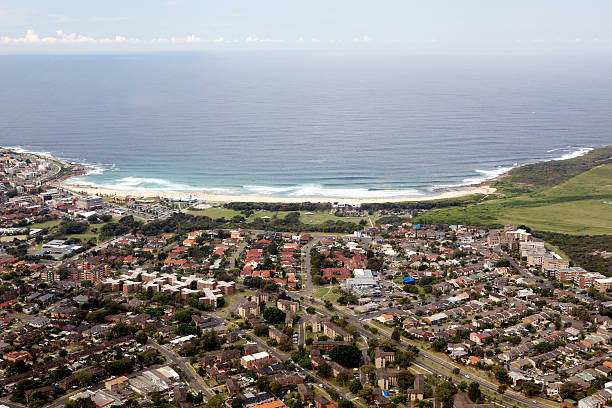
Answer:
420, 164, 612, 235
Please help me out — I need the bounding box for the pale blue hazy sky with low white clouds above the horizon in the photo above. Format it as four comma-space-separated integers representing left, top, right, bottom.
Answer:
0, 0, 612, 55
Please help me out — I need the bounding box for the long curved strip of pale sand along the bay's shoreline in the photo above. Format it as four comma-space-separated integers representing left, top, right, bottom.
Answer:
62, 183, 495, 204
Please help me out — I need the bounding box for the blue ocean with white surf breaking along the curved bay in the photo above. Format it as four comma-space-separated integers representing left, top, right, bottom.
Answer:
0, 52, 612, 198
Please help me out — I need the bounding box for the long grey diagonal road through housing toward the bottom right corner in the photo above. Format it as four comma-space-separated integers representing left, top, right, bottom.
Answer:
290, 294, 541, 408
